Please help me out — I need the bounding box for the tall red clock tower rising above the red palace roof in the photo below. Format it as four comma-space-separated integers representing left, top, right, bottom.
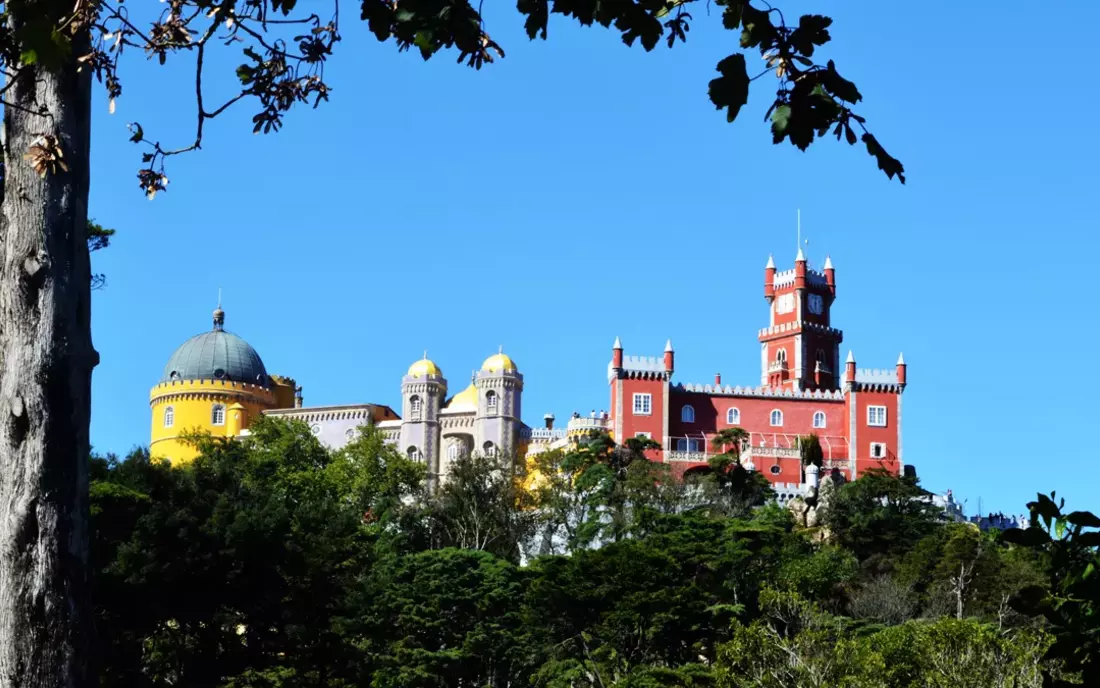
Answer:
759, 249, 844, 391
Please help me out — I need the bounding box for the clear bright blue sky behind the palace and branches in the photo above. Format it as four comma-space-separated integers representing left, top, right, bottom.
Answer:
91, 0, 1100, 513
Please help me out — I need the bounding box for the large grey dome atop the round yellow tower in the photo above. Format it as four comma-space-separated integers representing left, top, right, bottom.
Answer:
161, 321, 271, 387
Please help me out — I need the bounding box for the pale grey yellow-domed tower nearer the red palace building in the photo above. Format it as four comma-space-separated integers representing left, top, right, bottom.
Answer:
474, 350, 524, 457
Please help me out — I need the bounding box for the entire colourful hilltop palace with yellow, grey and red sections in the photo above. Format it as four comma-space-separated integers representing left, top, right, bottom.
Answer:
150, 250, 906, 488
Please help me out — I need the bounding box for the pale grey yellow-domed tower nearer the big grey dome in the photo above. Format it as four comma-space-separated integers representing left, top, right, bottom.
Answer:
398, 353, 447, 483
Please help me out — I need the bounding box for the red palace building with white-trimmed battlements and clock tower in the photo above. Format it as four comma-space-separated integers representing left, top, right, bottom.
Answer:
609, 251, 906, 483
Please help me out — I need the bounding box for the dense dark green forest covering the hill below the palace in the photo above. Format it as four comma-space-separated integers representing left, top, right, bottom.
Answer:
91, 419, 1100, 688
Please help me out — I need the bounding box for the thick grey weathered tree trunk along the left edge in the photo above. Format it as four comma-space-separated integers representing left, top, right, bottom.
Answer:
0, 13, 98, 688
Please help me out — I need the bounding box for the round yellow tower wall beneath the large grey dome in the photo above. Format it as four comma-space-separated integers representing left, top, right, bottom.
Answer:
149, 380, 277, 463
